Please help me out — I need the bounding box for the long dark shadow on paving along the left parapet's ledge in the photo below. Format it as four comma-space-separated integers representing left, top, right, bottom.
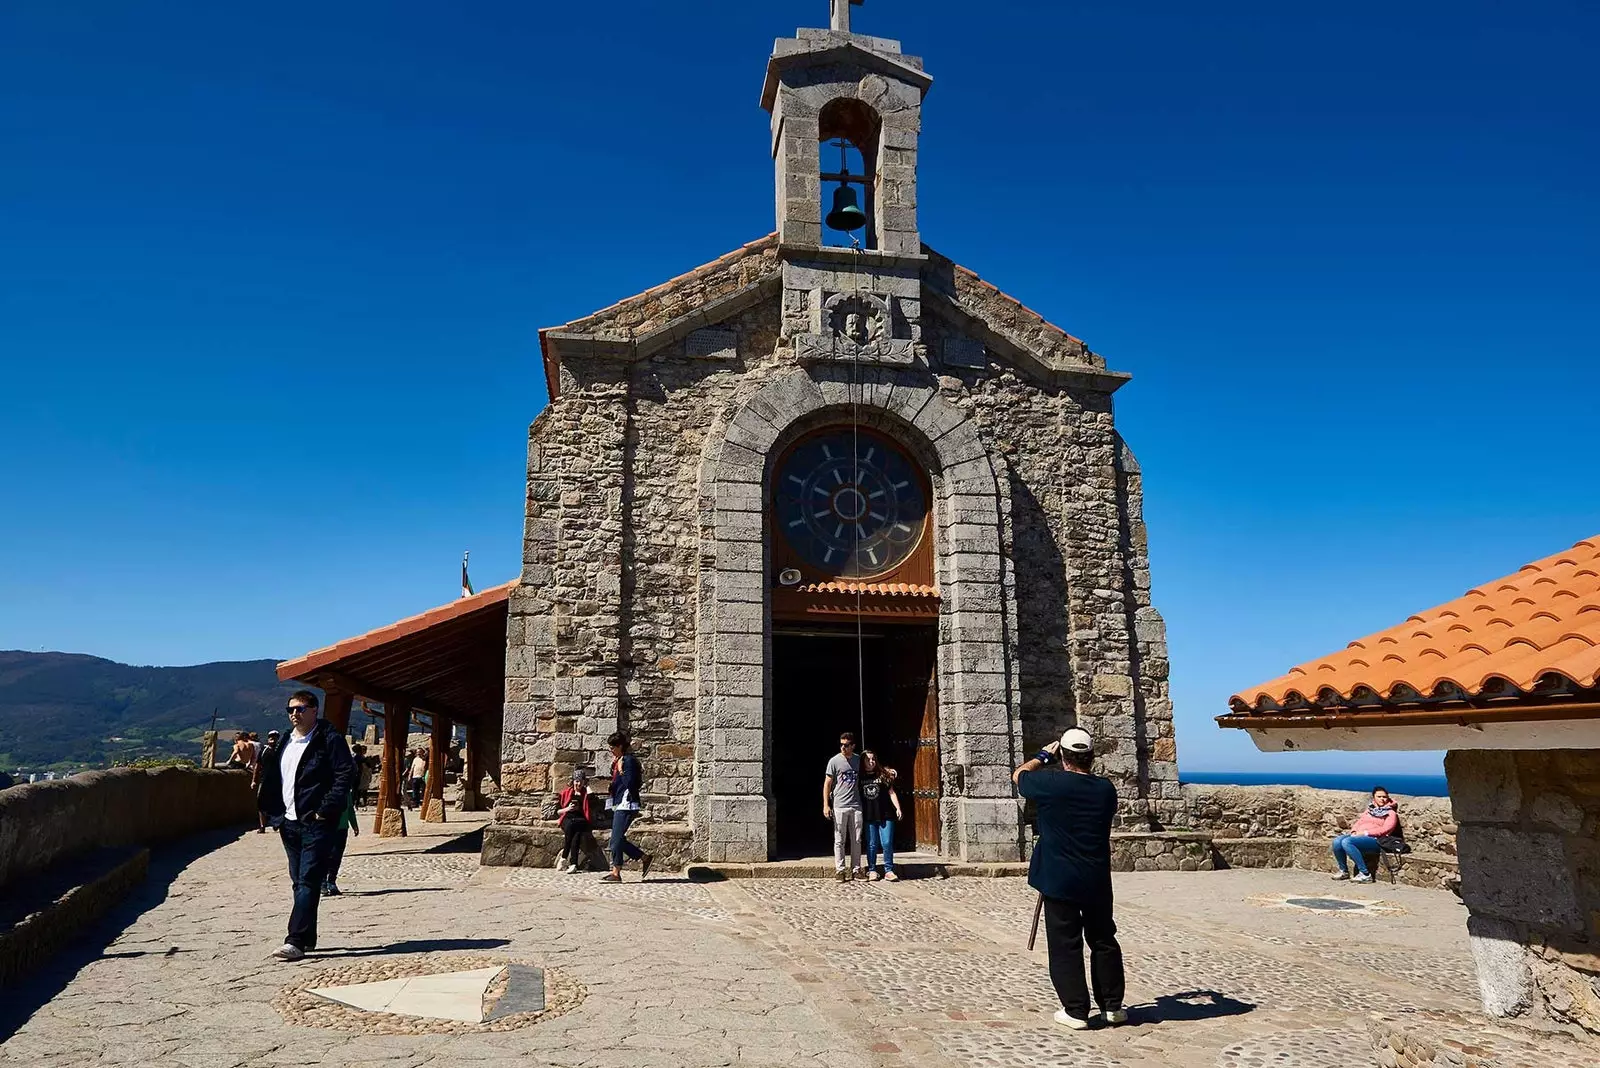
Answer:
0, 827, 256, 1039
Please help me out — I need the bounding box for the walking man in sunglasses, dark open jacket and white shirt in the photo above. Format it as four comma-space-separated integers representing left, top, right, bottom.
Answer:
259, 689, 355, 961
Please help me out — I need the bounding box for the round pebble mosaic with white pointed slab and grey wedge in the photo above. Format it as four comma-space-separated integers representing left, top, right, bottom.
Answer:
272, 956, 587, 1034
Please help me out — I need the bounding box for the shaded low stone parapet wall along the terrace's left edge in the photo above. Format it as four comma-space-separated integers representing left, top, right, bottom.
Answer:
0, 767, 256, 891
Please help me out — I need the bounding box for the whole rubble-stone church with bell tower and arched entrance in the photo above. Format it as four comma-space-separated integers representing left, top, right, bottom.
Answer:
488, 0, 1179, 862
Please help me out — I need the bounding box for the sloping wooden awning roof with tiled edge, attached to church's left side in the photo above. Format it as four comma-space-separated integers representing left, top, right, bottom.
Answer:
278, 582, 517, 723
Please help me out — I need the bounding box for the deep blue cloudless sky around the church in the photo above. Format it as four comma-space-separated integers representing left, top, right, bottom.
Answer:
0, 0, 1600, 771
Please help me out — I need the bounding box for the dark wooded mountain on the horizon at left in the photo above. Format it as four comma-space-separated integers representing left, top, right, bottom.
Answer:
0, 651, 296, 774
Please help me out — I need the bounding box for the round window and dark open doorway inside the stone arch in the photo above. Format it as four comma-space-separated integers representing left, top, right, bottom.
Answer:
766, 422, 941, 857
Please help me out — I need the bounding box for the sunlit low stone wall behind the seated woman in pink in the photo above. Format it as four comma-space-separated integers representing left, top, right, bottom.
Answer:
1184, 783, 1458, 889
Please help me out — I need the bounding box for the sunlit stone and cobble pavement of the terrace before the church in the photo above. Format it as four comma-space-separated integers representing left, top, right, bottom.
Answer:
0, 822, 1510, 1068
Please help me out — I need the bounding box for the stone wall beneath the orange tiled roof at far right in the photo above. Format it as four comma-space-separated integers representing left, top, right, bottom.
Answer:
1445, 750, 1600, 1034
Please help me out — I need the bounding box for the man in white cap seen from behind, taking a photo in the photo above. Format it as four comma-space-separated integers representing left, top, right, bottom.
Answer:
1011, 727, 1128, 1031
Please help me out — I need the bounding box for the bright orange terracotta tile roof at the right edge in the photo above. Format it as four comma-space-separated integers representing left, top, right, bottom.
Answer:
1229, 536, 1600, 711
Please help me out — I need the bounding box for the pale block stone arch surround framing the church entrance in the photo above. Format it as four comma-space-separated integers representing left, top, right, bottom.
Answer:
690, 366, 1022, 862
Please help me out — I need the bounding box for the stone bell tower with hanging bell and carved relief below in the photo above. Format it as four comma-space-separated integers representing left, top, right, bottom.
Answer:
762, 0, 933, 365
